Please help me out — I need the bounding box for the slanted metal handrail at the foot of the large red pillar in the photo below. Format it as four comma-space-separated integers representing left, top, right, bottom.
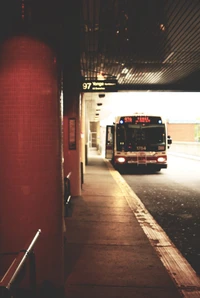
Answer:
0, 229, 41, 298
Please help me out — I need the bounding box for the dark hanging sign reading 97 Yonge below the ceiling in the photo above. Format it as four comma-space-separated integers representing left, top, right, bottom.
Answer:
81, 80, 118, 92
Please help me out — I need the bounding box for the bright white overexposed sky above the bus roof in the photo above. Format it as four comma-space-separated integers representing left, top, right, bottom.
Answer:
100, 91, 200, 126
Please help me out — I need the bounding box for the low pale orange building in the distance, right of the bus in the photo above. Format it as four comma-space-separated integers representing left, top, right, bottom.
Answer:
167, 119, 200, 142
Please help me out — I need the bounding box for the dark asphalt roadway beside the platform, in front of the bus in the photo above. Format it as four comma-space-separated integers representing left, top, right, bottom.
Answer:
122, 155, 200, 275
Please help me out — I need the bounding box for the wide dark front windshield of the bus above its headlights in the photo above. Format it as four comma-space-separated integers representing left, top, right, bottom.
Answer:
116, 124, 166, 151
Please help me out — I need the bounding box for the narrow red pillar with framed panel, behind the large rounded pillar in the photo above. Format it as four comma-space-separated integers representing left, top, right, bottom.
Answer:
63, 0, 81, 196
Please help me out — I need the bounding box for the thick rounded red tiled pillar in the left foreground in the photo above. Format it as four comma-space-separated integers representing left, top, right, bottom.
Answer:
0, 36, 64, 287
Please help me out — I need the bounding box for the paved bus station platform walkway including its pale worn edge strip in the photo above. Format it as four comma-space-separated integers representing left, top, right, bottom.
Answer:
64, 151, 200, 298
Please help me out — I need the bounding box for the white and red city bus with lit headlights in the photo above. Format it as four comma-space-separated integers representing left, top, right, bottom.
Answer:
105, 114, 172, 171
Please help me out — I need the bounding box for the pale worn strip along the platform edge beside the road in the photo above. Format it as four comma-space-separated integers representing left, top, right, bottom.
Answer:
104, 159, 200, 298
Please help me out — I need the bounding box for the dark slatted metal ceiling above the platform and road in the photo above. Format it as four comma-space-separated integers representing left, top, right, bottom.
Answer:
80, 0, 200, 90
